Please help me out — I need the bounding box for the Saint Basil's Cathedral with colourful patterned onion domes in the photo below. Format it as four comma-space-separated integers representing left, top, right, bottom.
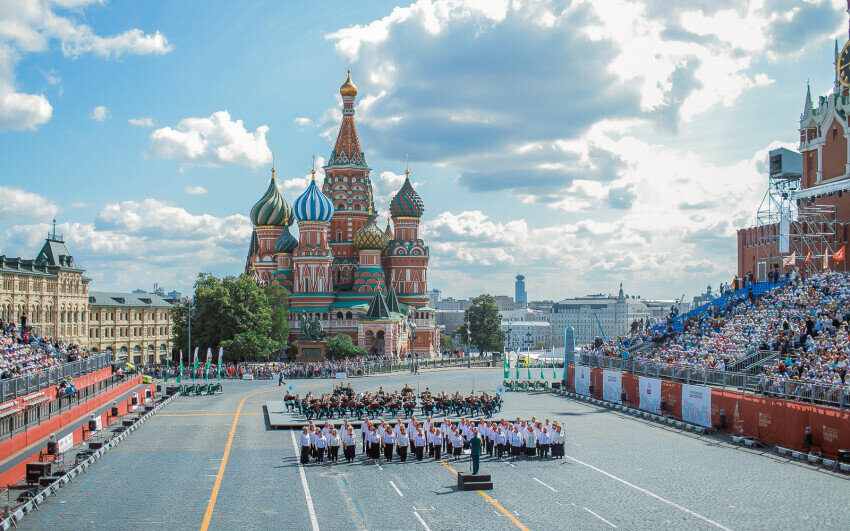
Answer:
240, 74, 439, 357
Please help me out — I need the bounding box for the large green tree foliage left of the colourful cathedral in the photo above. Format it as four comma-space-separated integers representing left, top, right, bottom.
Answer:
172, 273, 289, 361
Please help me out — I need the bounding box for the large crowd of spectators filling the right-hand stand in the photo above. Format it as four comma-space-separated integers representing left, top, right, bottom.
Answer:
616, 272, 850, 385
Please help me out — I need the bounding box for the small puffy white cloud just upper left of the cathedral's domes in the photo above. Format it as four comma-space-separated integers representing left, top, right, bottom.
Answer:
146, 111, 272, 167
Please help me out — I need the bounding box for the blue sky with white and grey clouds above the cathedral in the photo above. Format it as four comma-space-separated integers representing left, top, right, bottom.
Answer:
0, 0, 848, 300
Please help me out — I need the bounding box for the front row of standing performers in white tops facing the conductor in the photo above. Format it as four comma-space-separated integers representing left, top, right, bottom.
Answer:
300, 417, 565, 465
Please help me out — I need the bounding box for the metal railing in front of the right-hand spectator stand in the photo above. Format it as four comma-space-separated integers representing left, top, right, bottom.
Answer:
578, 353, 850, 409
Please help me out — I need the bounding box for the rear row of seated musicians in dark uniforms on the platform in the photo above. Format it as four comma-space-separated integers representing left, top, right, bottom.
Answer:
283, 388, 502, 420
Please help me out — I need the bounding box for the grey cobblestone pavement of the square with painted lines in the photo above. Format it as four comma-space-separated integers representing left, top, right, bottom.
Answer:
20, 369, 850, 531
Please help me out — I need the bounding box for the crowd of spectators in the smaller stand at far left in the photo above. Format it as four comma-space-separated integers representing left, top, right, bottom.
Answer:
0, 320, 88, 379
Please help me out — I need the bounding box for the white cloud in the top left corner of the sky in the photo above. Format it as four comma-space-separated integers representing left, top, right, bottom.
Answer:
0, 0, 171, 131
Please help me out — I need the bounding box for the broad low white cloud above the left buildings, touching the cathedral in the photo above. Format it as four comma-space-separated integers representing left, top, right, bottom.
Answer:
2, 199, 251, 291
